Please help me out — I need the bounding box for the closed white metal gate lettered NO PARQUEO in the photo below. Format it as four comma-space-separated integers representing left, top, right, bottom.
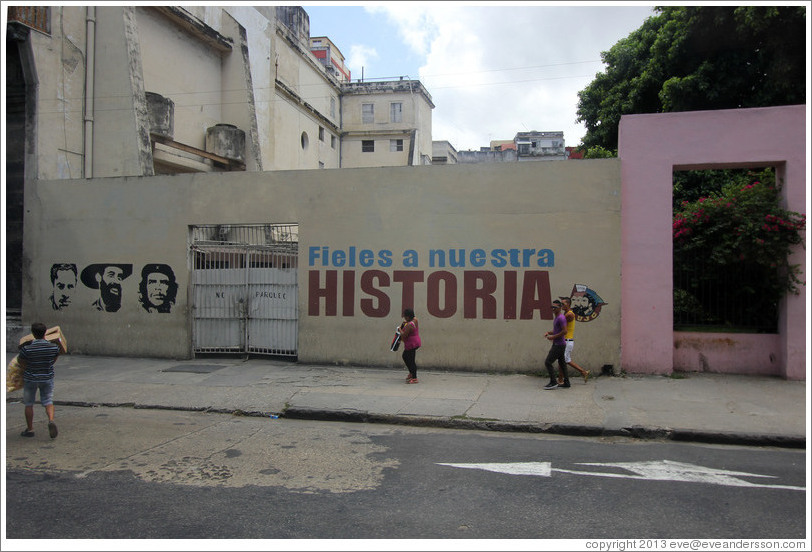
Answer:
190, 224, 299, 357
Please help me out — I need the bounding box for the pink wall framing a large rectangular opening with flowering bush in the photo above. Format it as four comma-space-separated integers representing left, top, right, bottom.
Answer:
618, 105, 807, 380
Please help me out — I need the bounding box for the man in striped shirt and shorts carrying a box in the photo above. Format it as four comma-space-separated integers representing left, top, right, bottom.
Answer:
19, 322, 59, 439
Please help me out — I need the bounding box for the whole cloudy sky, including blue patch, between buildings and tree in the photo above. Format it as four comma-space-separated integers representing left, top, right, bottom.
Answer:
301, 2, 655, 150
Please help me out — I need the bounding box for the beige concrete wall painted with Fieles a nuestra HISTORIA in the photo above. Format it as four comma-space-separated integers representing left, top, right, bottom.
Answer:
23, 160, 620, 371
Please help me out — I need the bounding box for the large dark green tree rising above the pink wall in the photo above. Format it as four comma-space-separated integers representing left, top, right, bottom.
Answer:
577, 5, 807, 150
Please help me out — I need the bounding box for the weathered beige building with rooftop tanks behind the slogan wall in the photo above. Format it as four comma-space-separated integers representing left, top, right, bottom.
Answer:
3, 5, 434, 308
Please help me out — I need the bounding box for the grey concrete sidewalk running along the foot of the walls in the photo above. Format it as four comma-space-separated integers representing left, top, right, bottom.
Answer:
6, 351, 807, 448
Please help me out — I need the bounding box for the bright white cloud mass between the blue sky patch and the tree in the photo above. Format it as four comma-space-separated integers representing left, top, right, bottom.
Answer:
367, 2, 653, 149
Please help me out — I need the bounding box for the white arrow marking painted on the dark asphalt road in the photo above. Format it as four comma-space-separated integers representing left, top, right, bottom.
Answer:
439, 460, 806, 491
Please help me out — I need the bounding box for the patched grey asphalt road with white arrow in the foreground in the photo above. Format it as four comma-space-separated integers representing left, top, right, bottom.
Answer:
6, 405, 807, 547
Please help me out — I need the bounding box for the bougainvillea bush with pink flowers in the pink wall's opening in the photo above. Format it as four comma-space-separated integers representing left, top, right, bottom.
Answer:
673, 169, 806, 331
